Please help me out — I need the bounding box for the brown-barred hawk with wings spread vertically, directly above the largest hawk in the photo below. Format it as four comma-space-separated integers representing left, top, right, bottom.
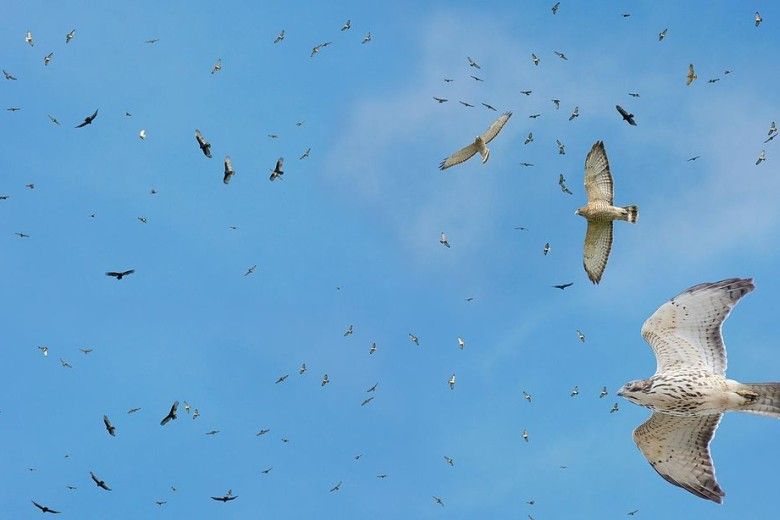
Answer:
575, 141, 639, 284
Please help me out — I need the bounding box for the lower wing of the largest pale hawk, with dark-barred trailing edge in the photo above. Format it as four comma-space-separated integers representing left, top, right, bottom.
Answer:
634, 413, 726, 504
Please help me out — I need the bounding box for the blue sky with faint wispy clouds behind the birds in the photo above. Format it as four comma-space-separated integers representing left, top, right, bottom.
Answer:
0, 1, 780, 519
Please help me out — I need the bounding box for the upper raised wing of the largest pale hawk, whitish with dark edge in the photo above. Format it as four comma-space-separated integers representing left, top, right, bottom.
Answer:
642, 278, 755, 375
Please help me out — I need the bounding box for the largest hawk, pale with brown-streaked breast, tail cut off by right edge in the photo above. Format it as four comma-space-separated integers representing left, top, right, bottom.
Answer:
618, 278, 780, 503
